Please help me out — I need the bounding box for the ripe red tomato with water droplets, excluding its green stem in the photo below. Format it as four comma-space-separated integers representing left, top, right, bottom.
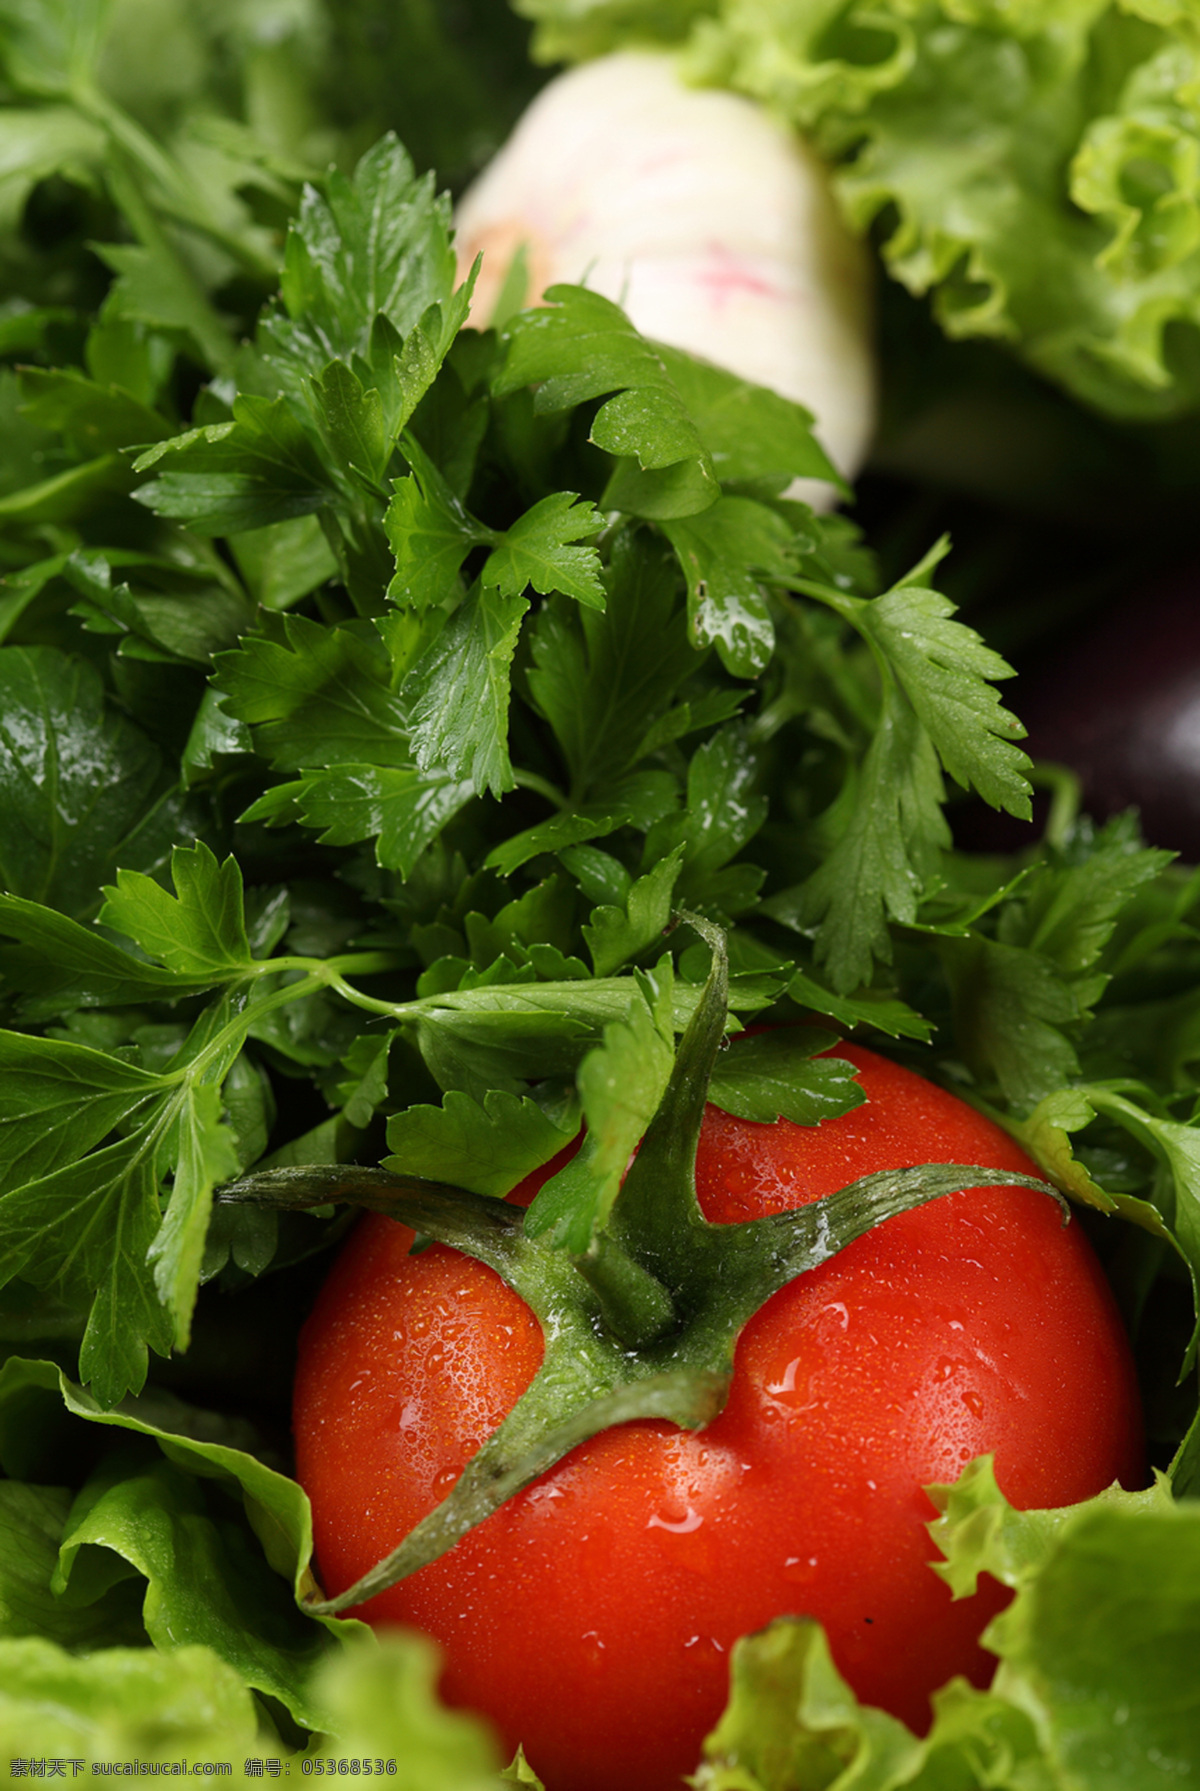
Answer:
296, 1046, 1143, 1791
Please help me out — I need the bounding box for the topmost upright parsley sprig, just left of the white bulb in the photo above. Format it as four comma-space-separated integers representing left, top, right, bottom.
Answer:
134, 138, 469, 613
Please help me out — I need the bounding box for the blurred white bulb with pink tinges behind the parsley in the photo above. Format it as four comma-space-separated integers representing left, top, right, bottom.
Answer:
455, 50, 876, 507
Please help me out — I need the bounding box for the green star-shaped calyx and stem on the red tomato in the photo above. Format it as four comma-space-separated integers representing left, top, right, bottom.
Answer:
219, 917, 1062, 1615
